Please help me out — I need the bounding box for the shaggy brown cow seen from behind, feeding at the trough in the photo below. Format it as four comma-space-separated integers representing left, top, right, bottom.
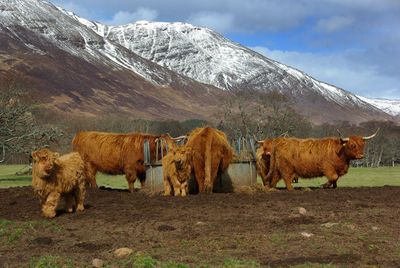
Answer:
185, 126, 232, 193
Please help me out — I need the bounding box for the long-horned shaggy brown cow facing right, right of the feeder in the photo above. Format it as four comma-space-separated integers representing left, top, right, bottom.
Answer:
266, 129, 379, 190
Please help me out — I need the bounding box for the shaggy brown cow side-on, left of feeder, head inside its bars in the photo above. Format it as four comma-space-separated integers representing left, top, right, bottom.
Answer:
72, 131, 175, 193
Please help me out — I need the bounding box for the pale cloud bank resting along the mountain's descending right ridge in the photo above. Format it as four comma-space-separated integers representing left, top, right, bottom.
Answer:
252, 47, 400, 99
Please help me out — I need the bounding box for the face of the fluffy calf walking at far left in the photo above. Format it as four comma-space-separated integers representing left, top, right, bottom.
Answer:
32, 149, 59, 178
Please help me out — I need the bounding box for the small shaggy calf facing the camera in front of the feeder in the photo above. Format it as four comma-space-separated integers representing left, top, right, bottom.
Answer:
162, 145, 192, 196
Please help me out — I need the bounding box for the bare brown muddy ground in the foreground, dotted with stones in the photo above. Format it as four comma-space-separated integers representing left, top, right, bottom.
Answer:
0, 186, 400, 267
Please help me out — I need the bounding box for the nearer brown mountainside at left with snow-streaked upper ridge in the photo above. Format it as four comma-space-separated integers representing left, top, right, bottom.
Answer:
0, 0, 225, 119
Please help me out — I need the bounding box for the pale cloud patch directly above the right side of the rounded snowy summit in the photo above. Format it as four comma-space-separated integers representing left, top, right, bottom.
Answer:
187, 12, 234, 33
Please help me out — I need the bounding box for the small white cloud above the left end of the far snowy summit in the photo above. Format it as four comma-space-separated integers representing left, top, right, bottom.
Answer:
103, 7, 158, 25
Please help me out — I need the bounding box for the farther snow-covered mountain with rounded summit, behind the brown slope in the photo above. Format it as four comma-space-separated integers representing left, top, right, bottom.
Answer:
77, 18, 391, 122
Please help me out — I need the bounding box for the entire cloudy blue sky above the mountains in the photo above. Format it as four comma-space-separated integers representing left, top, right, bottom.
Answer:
50, 0, 400, 99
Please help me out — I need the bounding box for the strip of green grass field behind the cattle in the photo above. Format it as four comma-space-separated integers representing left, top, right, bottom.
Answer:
0, 165, 400, 189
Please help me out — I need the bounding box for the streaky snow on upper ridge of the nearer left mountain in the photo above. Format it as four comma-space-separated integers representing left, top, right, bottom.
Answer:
0, 0, 182, 86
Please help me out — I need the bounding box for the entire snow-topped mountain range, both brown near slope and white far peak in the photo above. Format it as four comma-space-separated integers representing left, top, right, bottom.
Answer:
0, 0, 398, 123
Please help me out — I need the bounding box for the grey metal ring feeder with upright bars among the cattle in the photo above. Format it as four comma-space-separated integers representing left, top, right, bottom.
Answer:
144, 136, 257, 194
